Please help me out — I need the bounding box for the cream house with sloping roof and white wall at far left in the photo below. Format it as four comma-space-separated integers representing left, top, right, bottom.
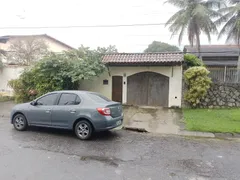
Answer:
0, 34, 74, 95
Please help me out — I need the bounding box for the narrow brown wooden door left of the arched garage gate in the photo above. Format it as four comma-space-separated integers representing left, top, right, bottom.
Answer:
112, 76, 123, 102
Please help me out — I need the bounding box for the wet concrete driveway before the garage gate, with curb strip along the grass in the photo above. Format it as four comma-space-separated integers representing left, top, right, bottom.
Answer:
123, 106, 215, 138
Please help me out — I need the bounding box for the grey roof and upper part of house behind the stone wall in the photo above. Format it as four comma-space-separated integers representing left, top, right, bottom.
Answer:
183, 45, 240, 67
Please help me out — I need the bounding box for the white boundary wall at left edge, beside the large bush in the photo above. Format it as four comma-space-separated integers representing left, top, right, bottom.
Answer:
0, 65, 25, 95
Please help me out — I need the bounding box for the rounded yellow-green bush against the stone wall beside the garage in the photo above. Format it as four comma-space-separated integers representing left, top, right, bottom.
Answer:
184, 67, 212, 107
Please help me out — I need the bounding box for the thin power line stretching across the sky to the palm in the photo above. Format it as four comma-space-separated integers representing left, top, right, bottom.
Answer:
0, 23, 166, 29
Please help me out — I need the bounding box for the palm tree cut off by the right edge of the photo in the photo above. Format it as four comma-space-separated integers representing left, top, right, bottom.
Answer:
215, 0, 240, 45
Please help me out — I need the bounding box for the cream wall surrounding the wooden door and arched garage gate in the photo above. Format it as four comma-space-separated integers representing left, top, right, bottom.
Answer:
80, 66, 182, 107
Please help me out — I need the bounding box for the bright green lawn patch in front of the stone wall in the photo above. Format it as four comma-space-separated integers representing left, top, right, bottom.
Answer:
183, 109, 240, 133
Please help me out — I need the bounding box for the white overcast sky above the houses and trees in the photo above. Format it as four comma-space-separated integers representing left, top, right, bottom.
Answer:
0, 0, 225, 52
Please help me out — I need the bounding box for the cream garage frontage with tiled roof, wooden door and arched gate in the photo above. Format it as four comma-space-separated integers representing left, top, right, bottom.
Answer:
80, 53, 183, 107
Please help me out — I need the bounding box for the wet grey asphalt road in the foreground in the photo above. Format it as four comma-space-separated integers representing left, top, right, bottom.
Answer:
0, 118, 240, 180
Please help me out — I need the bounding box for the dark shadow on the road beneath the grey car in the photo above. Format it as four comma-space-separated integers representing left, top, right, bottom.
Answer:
26, 127, 120, 141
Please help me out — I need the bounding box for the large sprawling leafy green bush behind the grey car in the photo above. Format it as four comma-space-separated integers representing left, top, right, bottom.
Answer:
9, 47, 105, 102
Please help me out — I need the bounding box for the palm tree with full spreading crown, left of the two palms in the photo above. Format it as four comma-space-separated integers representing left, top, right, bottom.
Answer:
166, 0, 222, 57
